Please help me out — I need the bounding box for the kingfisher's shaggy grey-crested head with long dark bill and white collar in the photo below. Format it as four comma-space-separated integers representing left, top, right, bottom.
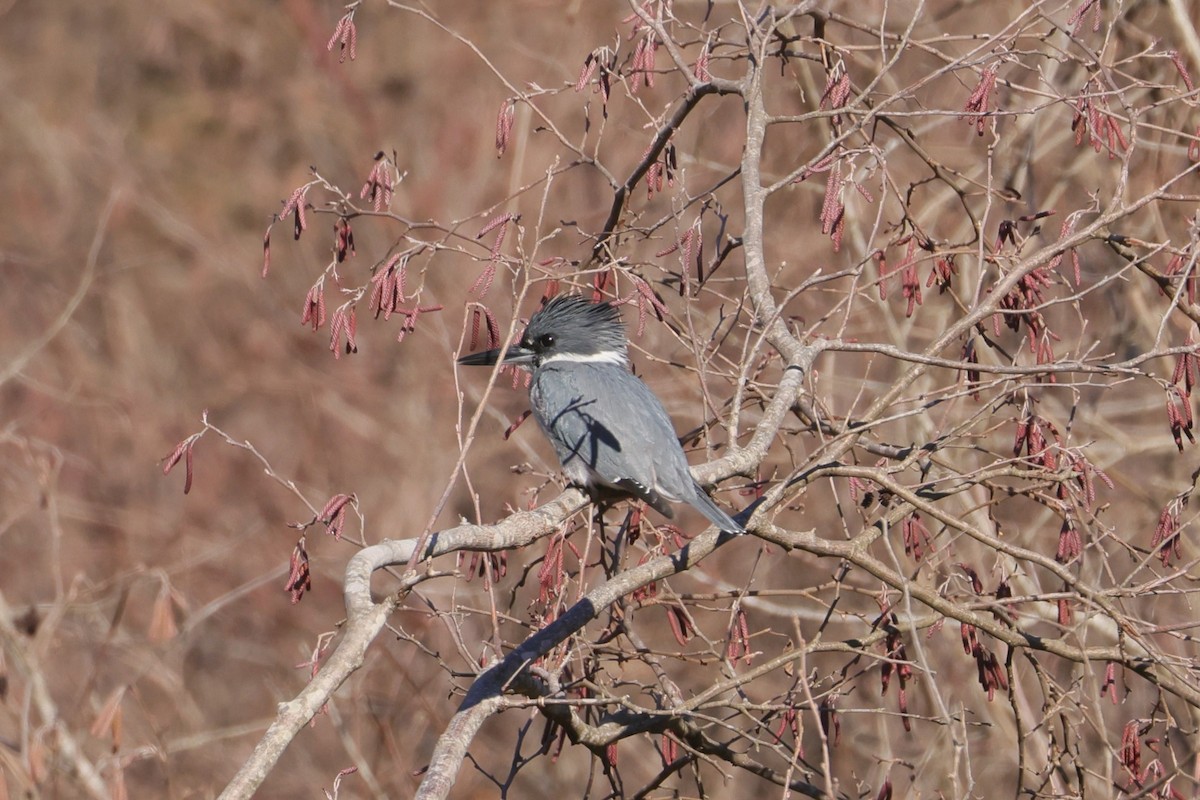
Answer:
458, 295, 629, 368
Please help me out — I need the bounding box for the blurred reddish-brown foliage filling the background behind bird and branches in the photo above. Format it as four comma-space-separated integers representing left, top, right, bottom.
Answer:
7, 0, 1200, 798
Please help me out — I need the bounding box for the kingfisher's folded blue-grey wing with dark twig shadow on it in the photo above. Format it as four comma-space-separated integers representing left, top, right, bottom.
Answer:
529, 363, 694, 503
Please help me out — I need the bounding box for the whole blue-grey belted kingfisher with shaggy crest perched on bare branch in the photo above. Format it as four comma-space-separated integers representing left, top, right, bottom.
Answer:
458, 295, 745, 534
